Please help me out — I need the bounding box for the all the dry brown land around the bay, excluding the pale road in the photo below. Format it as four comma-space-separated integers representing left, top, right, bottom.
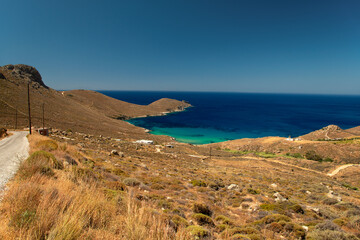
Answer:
0, 64, 360, 240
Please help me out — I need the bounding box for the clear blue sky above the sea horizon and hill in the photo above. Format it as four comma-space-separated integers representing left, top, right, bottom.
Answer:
0, 0, 360, 94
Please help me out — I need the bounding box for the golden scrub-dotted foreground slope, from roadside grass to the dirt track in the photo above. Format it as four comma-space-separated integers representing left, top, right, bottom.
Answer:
0, 133, 360, 240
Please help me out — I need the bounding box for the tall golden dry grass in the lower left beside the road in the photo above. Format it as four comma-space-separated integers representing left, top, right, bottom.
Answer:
0, 135, 191, 240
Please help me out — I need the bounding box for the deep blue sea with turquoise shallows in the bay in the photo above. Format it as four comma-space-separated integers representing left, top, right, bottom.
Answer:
100, 91, 360, 144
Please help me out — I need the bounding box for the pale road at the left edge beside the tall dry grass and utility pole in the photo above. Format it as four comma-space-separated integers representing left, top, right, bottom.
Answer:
0, 132, 29, 191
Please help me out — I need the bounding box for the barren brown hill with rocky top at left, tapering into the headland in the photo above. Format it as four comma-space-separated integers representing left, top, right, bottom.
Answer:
0, 64, 190, 138
